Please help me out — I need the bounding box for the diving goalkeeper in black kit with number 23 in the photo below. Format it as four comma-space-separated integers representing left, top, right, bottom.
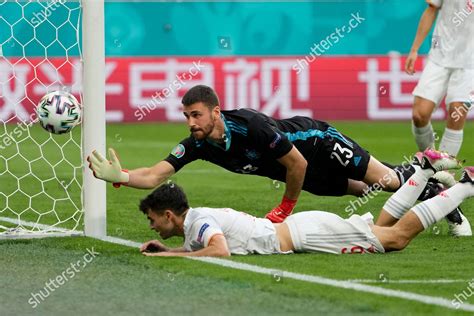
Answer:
88, 85, 469, 235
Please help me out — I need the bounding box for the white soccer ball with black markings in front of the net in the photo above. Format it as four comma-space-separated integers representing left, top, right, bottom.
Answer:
36, 91, 81, 134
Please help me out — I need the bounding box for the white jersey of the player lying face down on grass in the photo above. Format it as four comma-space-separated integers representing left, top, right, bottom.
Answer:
184, 207, 281, 255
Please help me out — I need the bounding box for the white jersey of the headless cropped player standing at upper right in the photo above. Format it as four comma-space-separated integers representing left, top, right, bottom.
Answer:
427, 0, 474, 69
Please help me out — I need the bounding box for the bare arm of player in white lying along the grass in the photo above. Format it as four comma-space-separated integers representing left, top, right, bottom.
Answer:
143, 234, 230, 257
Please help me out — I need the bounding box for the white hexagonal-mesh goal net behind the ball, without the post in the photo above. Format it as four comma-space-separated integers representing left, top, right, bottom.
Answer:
0, 0, 105, 238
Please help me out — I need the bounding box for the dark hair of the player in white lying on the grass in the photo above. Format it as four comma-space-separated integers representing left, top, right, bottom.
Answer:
140, 183, 189, 215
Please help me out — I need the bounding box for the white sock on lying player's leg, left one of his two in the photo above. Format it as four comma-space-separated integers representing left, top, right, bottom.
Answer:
383, 166, 434, 219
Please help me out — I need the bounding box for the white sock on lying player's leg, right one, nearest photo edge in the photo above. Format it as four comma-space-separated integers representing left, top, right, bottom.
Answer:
411, 183, 474, 229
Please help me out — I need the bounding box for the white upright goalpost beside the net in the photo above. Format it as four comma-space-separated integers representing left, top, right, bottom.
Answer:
82, 0, 107, 237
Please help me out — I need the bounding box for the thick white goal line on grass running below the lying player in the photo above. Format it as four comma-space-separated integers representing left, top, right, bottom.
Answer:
0, 218, 474, 312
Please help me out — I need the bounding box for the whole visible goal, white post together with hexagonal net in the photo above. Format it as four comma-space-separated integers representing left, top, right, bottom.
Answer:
0, 0, 107, 239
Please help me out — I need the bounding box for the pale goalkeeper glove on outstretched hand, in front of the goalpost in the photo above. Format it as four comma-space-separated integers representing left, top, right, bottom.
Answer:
87, 148, 130, 188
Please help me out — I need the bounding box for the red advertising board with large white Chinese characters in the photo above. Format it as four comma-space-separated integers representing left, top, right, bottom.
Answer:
0, 54, 473, 122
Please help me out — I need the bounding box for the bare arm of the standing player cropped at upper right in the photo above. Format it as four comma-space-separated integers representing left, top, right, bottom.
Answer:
405, 0, 439, 75
